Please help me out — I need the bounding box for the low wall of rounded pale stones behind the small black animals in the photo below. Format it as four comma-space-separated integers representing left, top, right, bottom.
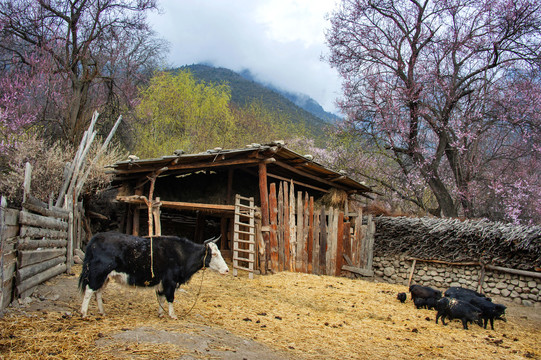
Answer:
373, 255, 541, 306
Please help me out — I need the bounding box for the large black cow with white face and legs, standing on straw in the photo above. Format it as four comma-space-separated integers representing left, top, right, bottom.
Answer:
79, 232, 229, 319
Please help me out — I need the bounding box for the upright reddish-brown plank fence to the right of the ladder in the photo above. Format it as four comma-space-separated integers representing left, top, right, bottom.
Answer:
259, 181, 375, 276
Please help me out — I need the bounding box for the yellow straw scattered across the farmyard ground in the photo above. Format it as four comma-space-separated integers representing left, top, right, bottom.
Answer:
0, 271, 541, 360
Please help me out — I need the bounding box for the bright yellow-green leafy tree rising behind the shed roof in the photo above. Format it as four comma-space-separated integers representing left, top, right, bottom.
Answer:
134, 71, 234, 157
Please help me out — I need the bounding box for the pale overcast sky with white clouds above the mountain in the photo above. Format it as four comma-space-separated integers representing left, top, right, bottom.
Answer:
150, 0, 341, 112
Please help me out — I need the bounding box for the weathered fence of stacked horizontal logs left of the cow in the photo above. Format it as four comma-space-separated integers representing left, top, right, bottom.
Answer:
0, 164, 86, 313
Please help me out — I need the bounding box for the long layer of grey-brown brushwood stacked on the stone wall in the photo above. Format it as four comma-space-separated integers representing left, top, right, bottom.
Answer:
374, 217, 541, 270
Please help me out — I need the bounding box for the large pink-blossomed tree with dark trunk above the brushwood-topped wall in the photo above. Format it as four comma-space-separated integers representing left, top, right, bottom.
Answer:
327, 0, 541, 220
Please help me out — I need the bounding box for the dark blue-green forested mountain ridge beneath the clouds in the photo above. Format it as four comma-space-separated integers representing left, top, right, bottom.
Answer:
180, 64, 329, 137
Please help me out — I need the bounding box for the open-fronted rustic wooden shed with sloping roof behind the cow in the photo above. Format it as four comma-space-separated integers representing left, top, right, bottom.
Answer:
107, 142, 371, 273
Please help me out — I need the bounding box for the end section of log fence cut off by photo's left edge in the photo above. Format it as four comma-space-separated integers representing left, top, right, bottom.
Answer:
0, 197, 19, 314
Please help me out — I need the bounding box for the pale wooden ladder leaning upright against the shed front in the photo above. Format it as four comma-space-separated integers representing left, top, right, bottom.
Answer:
233, 194, 256, 279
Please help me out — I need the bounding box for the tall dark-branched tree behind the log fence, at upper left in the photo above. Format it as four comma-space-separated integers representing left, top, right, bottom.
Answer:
0, 0, 165, 143
